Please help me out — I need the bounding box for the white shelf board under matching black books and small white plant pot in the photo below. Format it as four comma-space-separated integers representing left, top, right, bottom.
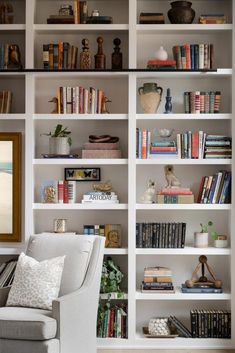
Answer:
135, 246, 231, 256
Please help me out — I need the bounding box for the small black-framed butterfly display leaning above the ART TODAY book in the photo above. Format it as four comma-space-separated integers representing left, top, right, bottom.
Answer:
64, 168, 100, 181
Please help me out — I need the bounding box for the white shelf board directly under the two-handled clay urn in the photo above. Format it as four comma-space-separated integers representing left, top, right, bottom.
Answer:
136, 113, 232, 121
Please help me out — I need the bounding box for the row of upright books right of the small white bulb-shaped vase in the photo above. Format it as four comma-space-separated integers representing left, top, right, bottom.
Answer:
172, 43, 214, 70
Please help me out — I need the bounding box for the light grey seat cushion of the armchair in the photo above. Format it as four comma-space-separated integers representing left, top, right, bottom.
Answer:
0, 307, 57, 340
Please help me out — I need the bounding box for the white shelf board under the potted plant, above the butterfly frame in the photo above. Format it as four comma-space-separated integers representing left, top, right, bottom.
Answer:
33, 158, 128, 166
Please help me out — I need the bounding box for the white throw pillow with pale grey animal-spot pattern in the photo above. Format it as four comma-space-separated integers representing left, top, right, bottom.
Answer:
6, 253, 65, 310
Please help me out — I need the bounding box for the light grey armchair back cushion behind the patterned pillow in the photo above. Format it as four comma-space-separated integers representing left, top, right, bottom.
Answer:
27, 234, 95, 296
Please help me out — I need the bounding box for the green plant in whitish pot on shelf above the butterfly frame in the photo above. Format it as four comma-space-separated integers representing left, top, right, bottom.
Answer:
43, 124, 72, 155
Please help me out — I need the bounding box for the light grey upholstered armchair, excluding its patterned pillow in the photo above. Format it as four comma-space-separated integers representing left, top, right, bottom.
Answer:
0, 234, 104, 353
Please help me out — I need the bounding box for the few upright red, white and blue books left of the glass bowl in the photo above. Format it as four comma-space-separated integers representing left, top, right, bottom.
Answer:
136, 128, 151, 159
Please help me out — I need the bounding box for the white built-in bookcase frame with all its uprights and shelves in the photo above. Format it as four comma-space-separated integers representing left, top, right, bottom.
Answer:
0, 0, 235, 349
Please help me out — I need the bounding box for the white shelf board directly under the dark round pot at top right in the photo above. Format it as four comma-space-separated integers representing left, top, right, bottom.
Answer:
136, 24, 233, 35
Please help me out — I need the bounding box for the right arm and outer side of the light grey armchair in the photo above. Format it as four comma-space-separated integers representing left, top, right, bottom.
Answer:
52, 235, 104, 353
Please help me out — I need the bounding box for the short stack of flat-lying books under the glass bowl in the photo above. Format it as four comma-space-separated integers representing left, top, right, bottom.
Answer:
149, 140, 177, 158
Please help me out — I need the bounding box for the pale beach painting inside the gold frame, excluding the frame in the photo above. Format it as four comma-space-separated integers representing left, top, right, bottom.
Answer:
0, 141, 13, 234
